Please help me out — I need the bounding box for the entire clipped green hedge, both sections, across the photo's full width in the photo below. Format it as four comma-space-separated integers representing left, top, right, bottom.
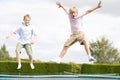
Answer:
0, 61, 120, 75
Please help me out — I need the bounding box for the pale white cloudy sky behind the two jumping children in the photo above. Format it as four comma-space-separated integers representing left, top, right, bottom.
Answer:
0, 0, 120, 63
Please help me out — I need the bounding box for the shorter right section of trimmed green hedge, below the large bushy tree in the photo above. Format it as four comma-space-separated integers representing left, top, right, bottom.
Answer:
81, 64, 120, 74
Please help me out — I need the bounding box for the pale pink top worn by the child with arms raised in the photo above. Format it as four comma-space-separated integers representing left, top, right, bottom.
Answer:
67, 12, 86, 34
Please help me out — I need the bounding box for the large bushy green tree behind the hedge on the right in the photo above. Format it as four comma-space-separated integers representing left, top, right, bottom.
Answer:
90, 37, 120, 64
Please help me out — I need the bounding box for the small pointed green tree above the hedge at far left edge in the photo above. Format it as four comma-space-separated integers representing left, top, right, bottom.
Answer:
0, 44, 10, 60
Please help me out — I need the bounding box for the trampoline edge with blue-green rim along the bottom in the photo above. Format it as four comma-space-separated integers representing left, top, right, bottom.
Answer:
0, 74, 120, 80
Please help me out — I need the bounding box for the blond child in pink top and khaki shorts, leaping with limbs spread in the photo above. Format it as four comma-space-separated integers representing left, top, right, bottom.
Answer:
52, 1, 101, 63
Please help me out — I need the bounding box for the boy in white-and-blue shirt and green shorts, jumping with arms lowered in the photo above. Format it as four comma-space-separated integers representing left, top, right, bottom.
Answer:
6, 14, 37, 69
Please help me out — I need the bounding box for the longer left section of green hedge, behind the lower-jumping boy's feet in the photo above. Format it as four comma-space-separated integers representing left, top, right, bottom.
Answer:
0, 61, 80, 75
